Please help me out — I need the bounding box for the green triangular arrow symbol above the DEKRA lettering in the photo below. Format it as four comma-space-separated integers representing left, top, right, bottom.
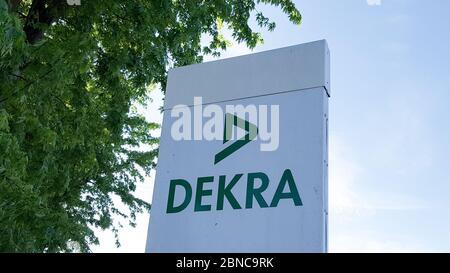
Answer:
214, 113, 258, 165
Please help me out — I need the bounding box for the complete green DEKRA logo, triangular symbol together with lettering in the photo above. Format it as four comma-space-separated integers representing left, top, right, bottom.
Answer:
166, 113, 303, 213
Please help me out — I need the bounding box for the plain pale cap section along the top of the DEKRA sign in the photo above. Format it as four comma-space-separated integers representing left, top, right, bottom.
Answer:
164, 40, 330, 109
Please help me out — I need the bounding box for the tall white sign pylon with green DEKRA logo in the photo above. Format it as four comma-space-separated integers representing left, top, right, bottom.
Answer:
146, 40, 330, 252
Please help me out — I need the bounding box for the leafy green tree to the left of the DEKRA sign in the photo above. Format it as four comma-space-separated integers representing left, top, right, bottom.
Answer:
0, 0, 301, 252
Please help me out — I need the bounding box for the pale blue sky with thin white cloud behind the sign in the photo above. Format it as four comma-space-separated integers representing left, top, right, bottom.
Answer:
93, 0, 450, 252
